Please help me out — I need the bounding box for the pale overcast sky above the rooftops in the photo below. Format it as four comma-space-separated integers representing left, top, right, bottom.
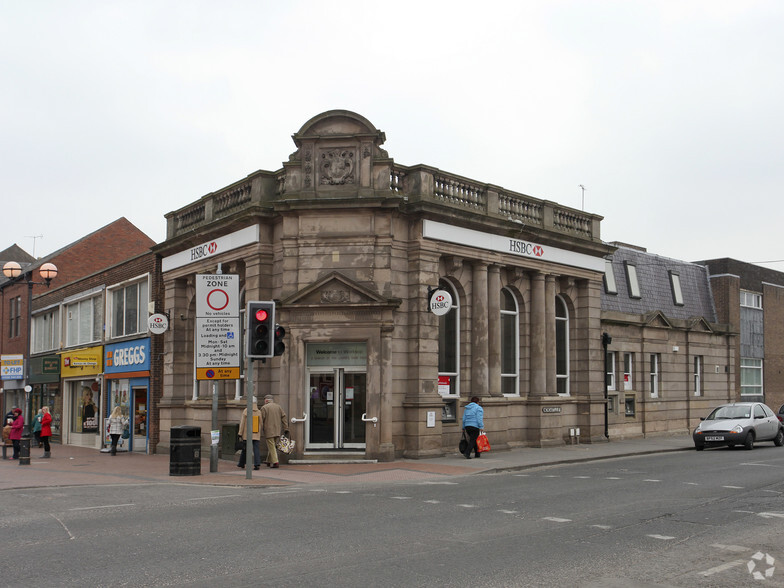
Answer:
0, 0, 784, 271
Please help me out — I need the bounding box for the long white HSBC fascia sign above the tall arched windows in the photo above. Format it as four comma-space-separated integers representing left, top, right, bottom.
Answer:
422, 220, 604, 273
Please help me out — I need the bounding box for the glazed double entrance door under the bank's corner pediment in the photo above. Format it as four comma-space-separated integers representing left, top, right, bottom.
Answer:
307, 368, 367, 449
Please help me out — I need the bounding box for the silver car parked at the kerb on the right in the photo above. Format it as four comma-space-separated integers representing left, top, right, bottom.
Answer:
692, 402, 784, 451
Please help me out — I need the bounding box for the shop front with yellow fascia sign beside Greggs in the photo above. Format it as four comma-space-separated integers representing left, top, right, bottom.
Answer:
60, 346, 103, 449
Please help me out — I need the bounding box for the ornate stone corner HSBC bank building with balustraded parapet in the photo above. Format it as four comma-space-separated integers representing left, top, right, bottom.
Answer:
155, 110, 614, 461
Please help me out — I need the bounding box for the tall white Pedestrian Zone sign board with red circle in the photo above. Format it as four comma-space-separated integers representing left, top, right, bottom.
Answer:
196, 274, 242, 380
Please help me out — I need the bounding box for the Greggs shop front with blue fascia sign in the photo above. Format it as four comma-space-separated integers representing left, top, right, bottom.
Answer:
102, 337, 150, 453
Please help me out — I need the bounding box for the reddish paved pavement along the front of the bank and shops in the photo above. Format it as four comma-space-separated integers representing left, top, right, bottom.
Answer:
0, 433, 694, 490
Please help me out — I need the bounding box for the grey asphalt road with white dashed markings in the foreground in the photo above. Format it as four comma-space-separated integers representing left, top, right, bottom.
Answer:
0, 444, 784, 588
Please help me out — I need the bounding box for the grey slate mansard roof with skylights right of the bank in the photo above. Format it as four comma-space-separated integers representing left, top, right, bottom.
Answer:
602, 243, 718, 323
